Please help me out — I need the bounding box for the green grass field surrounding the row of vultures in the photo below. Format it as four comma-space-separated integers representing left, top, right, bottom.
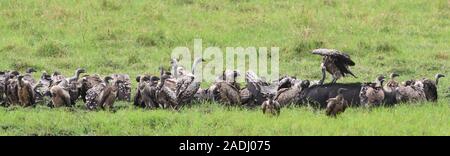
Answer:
0, 0, 450, 135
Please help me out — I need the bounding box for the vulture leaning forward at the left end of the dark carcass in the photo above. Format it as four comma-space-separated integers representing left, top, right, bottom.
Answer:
275, 79, 309, 106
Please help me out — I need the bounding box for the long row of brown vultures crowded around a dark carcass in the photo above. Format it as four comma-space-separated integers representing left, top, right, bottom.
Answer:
0, 49, 444, 117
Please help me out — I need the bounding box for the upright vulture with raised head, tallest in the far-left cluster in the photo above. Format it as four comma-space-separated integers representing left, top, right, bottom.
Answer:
67, 68, 86, 105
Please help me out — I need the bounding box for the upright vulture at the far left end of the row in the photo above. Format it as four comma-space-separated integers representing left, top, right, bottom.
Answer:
5, 71, 20, 105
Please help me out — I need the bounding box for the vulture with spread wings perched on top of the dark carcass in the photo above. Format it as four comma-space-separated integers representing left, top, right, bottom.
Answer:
312, 49, 356, 85
